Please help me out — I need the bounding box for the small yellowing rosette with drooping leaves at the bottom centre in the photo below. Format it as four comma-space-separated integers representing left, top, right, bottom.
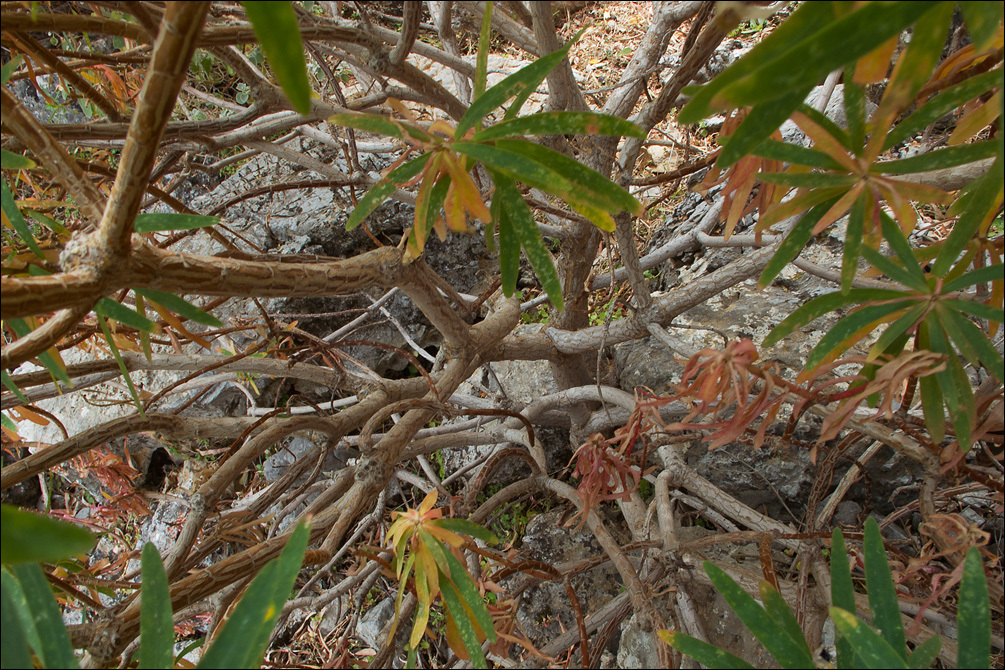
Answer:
387, 489, 498, 668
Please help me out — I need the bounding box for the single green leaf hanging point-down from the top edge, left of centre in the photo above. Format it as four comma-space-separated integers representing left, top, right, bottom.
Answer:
241, 2, 311, 115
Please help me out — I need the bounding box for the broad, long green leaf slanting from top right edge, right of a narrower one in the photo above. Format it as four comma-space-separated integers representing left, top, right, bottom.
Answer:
716, 2, 938, 107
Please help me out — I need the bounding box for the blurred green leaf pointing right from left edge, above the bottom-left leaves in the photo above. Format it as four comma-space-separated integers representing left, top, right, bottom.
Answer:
0, 505, 97, 566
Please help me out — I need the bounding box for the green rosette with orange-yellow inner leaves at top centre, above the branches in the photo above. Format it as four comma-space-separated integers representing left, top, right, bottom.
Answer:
330, 25, 644, 309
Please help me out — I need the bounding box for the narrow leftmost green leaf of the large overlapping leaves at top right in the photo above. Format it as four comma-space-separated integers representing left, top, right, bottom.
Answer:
677, 2, 837, 125
